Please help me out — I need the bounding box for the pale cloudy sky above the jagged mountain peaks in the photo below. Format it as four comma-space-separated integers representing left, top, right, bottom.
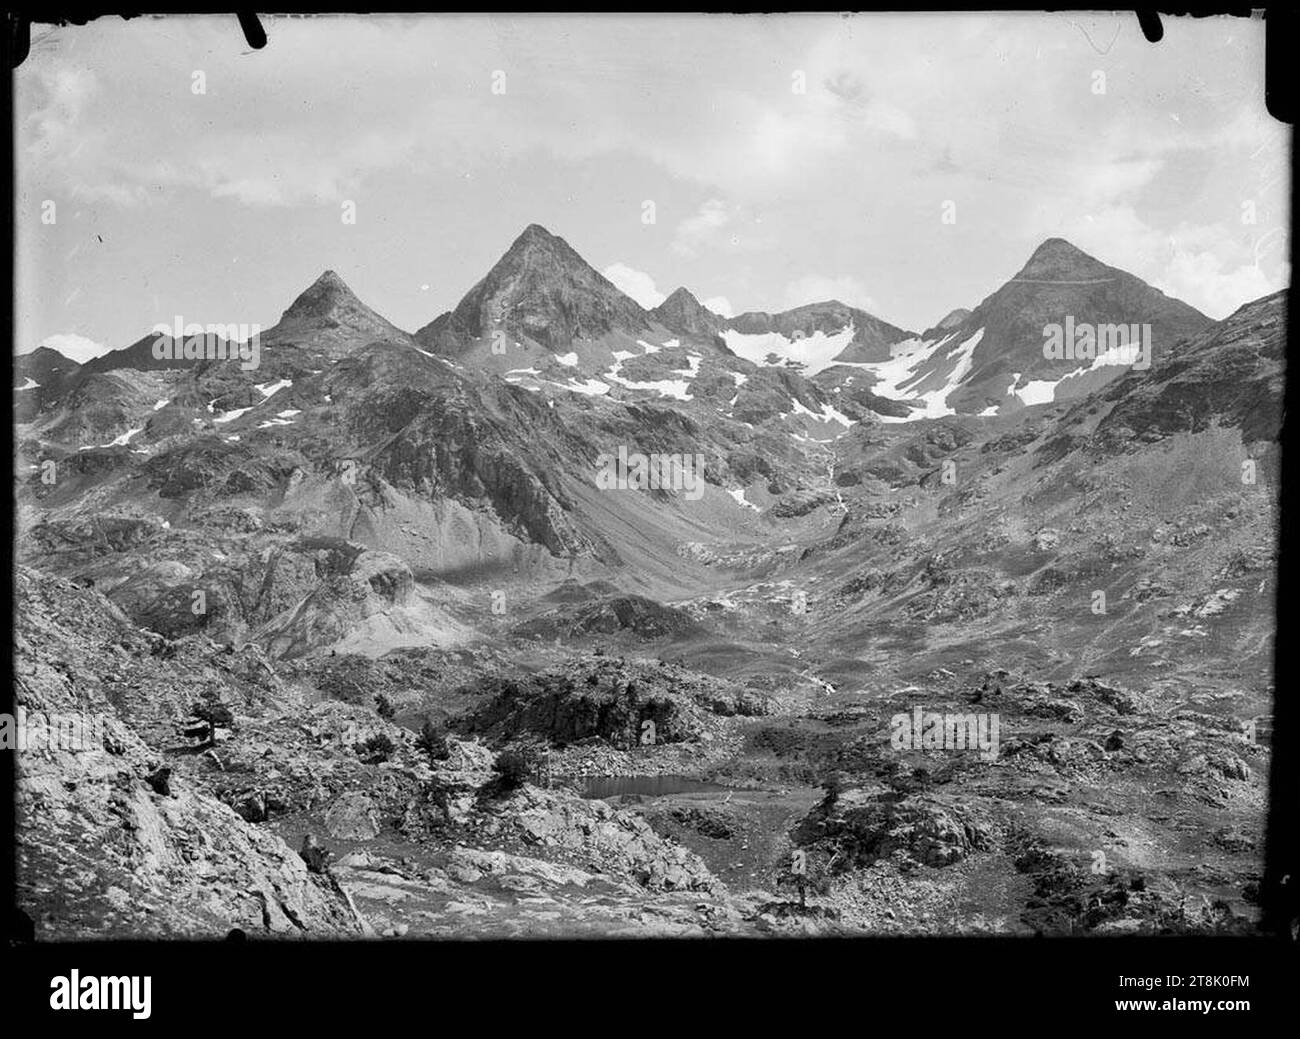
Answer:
14, 13, 1291, 360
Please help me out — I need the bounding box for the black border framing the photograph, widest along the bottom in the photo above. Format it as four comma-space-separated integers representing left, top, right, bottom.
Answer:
0, 3, 1300, 1031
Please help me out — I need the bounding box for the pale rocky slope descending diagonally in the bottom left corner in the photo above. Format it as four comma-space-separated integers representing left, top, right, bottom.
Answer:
14, 568, 361, 939
